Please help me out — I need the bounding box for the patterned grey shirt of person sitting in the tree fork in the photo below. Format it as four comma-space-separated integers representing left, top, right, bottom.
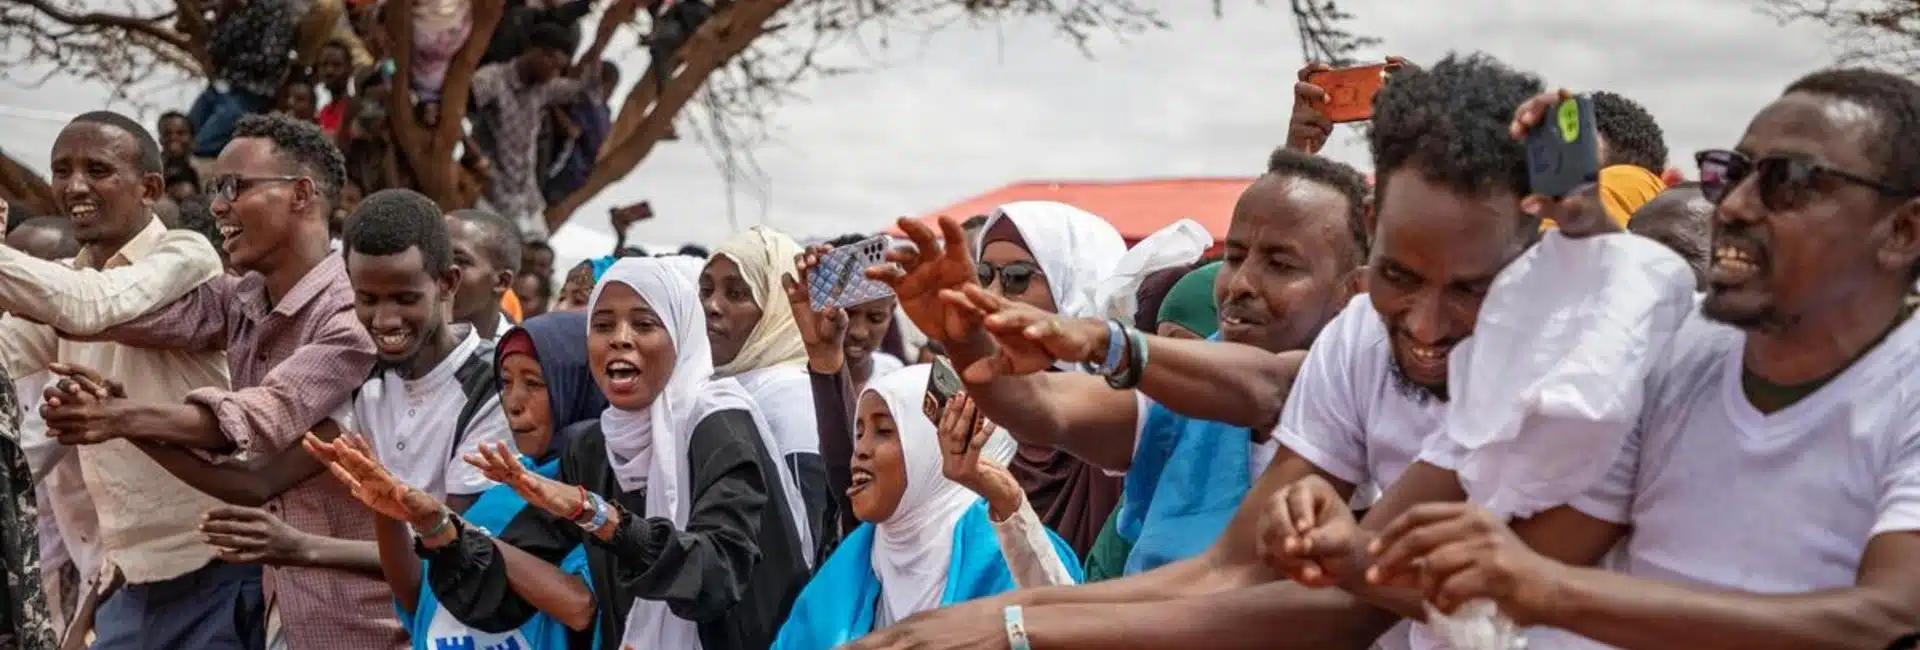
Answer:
472, 61, 599, 238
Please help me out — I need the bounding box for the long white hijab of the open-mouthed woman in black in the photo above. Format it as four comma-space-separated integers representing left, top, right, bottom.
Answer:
588, 257, 814, 650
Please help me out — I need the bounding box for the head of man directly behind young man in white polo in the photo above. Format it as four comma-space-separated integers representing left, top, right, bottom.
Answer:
445, 209, 520, 341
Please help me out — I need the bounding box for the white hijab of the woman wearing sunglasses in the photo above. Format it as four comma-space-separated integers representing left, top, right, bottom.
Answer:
973, 201, 1127, 318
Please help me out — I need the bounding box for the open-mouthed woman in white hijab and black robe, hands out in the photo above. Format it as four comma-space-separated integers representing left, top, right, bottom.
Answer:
430, 257, 812, 650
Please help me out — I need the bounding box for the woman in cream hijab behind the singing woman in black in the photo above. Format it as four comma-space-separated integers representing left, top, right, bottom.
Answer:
699, 226, 831, 556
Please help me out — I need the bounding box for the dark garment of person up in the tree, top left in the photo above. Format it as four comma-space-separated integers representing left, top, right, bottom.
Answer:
207, 0, 311, 98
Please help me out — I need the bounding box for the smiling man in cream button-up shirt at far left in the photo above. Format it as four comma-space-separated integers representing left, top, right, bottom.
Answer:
0, 111, 238, 648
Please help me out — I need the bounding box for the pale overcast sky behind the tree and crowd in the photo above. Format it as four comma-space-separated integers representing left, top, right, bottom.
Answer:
0, 0, 1834, 251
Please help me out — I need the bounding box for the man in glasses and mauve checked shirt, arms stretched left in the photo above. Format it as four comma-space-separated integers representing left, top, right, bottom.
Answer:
46, 115, 405, 650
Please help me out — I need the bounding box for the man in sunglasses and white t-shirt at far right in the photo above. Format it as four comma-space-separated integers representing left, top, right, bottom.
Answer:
1377, 69, 1920, 650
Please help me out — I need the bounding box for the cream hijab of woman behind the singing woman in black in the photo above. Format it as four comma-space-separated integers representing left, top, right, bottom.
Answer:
710, 226, 806, 378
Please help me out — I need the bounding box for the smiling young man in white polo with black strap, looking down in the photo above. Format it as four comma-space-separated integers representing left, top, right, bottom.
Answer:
344, 206, 511, 508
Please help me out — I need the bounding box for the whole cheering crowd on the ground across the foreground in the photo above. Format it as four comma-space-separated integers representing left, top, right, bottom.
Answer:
0, 25, 1920, 650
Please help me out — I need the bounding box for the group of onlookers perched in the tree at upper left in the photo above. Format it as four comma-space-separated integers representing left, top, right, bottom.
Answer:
142, 0, 683, 255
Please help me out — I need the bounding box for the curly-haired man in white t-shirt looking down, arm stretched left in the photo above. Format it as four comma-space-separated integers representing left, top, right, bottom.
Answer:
858, 56, 1643, 648
